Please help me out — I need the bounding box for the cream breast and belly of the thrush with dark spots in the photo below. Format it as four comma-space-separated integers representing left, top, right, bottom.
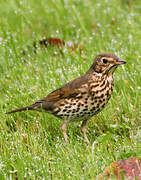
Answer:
54, 74, 113, 121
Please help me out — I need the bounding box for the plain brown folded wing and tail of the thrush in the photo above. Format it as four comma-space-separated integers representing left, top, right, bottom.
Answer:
7, 74, 89, 114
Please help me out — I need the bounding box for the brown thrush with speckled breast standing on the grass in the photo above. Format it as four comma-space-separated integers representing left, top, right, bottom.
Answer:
6, 53, 126, 144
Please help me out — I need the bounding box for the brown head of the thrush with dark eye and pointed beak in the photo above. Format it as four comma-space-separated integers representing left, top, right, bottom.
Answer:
91, 53, 126, 75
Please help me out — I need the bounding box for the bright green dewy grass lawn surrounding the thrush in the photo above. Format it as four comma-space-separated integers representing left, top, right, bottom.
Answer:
0, 0, 141, 180
